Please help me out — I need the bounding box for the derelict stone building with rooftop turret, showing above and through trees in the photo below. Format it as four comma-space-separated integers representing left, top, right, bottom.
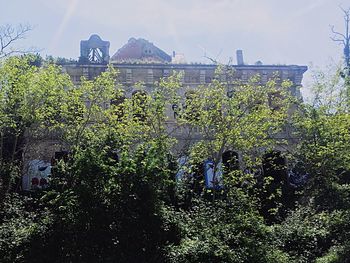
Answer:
22, 35, 307, 190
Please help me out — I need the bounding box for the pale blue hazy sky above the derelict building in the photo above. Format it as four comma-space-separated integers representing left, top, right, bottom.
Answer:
0, 0, 350, 94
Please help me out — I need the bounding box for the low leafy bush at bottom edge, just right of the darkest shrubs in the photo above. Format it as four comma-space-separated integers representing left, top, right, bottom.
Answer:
168, 190, 280, 262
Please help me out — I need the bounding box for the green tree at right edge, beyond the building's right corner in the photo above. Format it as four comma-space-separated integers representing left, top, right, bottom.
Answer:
273, 65, 350, 262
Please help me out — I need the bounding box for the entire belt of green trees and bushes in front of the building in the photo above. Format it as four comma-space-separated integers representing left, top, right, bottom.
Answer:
0, 56, 350, 263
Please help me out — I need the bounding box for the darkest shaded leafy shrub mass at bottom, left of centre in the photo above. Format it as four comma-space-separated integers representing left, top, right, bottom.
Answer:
19, 141, 176, 262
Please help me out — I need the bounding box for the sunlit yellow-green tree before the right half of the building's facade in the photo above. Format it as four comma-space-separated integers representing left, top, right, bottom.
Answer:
172, 67, 292, 223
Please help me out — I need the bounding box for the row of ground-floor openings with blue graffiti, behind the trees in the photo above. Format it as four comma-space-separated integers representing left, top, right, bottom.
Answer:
22, 150, 308, 190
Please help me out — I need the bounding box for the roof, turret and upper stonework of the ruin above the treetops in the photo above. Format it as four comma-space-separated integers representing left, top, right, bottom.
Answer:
62, 35, 307, 98
